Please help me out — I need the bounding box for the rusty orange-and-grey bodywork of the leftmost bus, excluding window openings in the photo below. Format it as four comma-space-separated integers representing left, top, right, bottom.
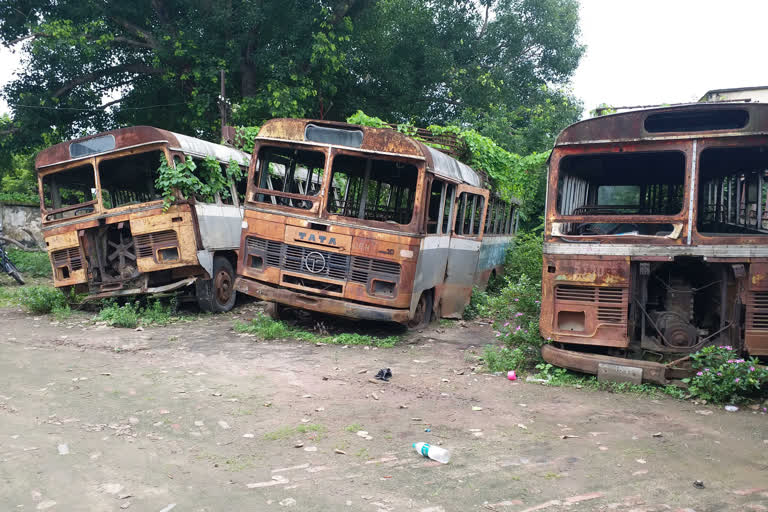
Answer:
36, 126, 250, 298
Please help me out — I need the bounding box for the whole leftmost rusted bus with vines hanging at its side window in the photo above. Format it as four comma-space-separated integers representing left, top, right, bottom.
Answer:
35, 126, 249, 312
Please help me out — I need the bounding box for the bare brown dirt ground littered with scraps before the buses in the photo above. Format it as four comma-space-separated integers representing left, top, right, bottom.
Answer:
0, 296, 768, 512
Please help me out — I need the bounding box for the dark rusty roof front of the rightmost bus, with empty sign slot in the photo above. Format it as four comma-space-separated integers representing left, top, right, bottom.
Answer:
555, 103, 768, 147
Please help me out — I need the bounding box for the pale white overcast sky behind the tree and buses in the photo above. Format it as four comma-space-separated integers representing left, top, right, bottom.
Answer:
0, 0, 768, 115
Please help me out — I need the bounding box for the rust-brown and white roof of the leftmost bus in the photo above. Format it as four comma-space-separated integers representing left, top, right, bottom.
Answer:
35, 126, 250, 170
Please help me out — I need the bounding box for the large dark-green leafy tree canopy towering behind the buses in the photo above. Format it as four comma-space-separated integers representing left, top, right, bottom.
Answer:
0, 0, 583, 156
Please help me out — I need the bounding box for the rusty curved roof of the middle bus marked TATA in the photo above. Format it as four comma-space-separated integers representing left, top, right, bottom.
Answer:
256, 119, 483, 187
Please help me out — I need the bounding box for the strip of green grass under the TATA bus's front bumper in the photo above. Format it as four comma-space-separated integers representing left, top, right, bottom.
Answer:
234, 314, 400, 348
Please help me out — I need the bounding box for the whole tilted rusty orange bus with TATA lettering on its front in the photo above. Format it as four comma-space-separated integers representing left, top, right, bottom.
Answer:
236, 119, 516, 327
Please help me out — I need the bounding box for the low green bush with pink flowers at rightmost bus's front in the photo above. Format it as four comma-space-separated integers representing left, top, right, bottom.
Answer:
683, 345, 768, 403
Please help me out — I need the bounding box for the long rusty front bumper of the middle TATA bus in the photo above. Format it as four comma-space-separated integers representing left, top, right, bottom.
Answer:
235, 277, 409, 324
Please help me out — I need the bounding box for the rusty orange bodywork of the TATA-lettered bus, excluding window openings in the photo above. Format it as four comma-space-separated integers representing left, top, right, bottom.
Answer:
236, 119, 510, 323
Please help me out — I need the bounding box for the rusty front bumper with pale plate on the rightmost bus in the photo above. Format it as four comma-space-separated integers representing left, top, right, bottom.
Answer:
541, 345, 691, 386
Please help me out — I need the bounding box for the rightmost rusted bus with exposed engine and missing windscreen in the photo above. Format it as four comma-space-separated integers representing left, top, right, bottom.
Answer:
540, 104, 768, 383
